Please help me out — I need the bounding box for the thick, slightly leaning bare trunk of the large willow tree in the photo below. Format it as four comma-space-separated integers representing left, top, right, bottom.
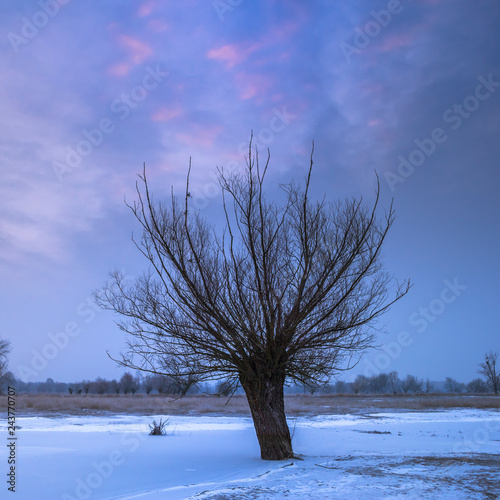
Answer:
242, 377, 293, 460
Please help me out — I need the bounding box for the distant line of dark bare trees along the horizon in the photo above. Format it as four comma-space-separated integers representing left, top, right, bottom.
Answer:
5, 371, 493, 396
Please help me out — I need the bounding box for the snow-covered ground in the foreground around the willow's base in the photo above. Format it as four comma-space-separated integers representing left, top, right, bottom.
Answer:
0, 409, 500, 500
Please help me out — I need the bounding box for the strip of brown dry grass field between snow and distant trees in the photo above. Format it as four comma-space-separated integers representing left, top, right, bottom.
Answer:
0, 394, 500, 416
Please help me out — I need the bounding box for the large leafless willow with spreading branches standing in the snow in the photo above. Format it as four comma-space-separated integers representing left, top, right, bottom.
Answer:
96, 142, 409, 460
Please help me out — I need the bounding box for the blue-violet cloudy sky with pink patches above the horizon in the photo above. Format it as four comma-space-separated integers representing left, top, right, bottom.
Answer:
0, 0, 500, 382
